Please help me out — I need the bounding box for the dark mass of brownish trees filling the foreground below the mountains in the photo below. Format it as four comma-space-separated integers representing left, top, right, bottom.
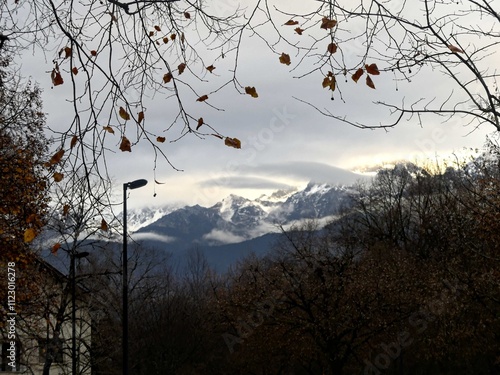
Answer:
88, 145, 500, 375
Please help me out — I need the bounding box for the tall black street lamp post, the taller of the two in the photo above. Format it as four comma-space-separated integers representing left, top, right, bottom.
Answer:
122, 179, 148, 375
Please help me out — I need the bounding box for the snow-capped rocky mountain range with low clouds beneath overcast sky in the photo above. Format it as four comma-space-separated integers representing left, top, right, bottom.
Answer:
130, 182, 348, 248
